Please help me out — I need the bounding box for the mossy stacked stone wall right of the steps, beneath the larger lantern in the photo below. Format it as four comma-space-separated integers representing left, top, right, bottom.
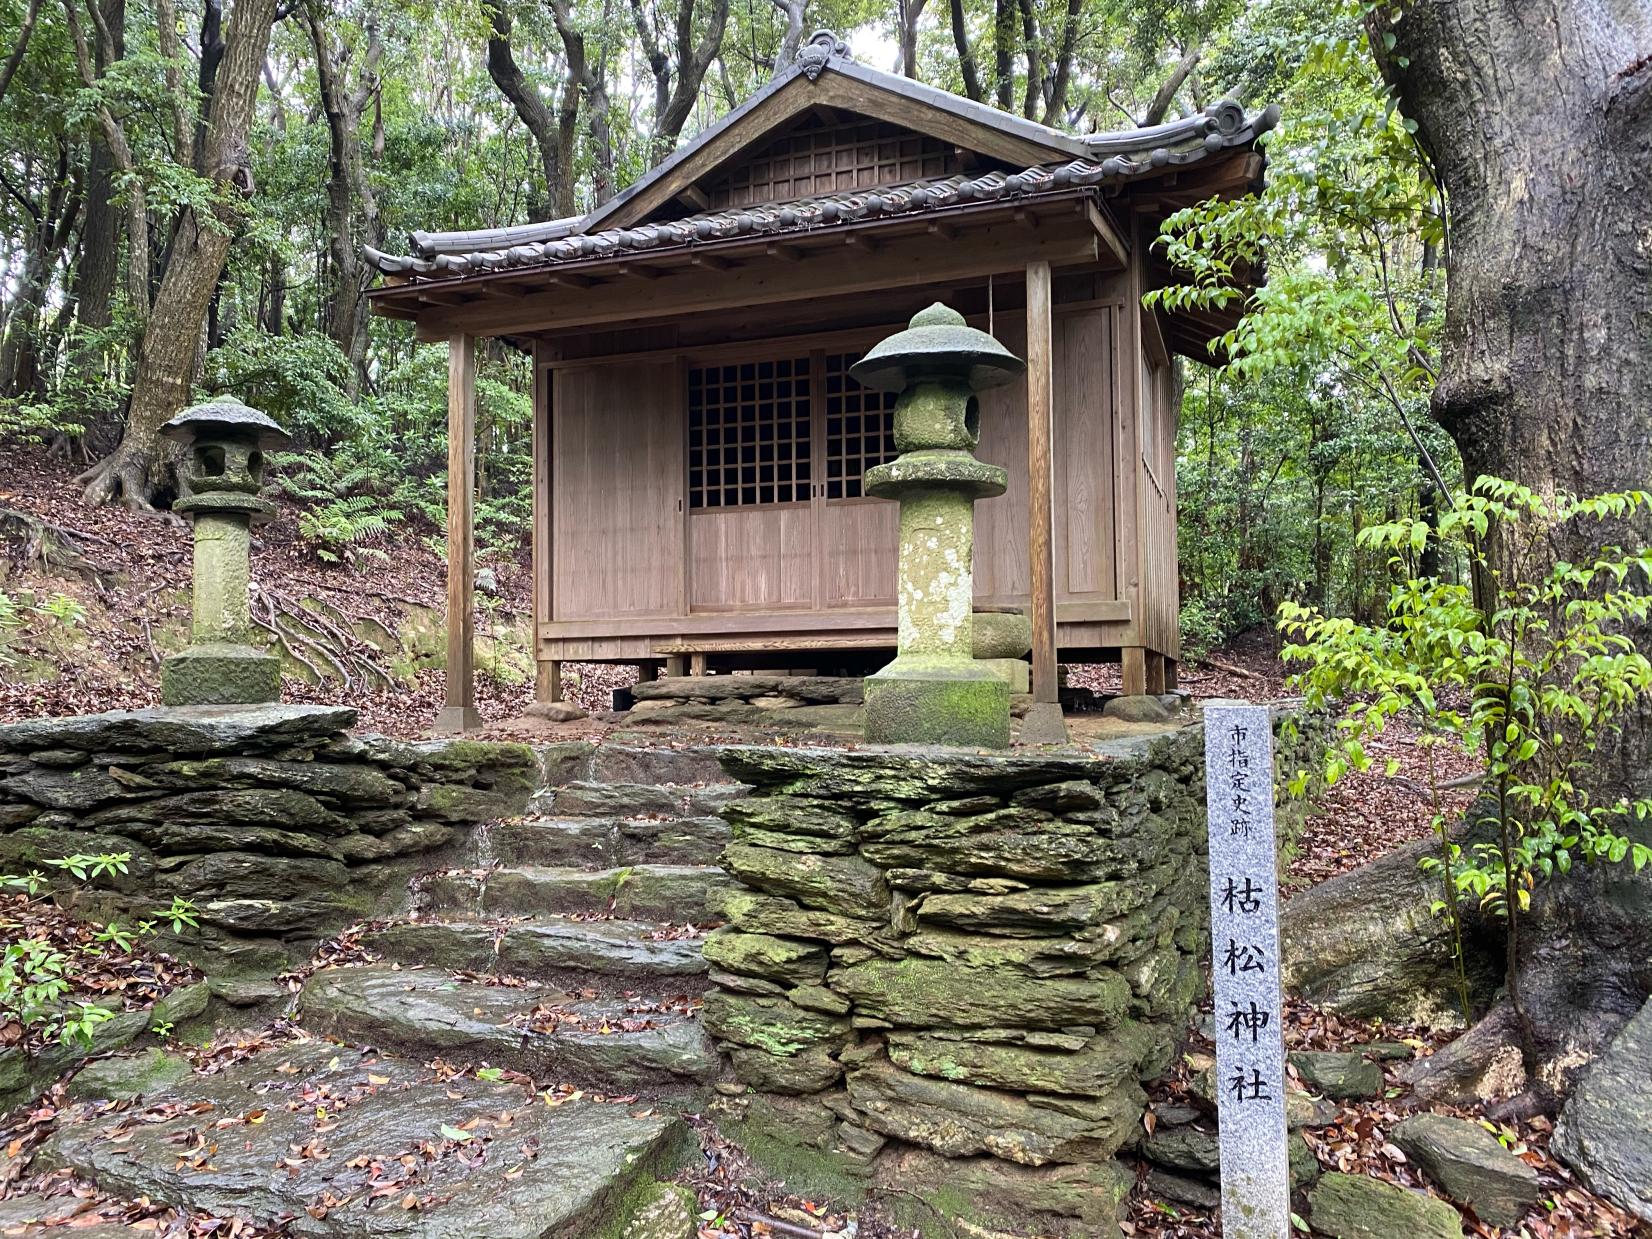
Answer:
704, 713, 1300, 1234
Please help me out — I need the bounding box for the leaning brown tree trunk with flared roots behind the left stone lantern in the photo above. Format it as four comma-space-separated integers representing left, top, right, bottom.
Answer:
81, 0, 276, 507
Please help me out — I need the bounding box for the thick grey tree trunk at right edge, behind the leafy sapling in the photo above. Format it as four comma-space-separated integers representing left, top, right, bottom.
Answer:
1371, 0, 1652, 1089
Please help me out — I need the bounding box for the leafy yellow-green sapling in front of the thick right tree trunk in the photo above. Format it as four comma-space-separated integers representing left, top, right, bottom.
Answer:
1280, 477, 1652, 1017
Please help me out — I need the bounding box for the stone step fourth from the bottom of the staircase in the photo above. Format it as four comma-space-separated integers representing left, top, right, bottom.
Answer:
413, 864, 735, 925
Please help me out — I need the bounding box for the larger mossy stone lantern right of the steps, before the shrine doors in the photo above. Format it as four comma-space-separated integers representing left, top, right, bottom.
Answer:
849, 302, 1026, 748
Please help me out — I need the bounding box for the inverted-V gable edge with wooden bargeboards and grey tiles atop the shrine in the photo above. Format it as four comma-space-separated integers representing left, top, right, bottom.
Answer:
578, 55, 1085, 233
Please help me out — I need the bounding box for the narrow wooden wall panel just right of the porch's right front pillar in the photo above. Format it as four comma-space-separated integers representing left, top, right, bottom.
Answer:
1056, 306, 1118, 600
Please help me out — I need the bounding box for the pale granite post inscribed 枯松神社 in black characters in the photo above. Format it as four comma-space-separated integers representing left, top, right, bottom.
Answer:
1204, 704, 1290, 1239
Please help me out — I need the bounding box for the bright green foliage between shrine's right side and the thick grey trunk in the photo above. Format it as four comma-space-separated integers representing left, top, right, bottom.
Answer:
1146, 0, 1460, 629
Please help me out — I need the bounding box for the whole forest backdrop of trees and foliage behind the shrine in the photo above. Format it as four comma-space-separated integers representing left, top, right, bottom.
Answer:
0, 0, 1457, 648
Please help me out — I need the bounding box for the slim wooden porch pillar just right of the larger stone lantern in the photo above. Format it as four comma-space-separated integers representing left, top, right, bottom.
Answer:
1028, 263, 1061, 704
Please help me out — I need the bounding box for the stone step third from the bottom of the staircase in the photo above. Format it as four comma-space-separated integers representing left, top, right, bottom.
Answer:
362, 920, 705, 991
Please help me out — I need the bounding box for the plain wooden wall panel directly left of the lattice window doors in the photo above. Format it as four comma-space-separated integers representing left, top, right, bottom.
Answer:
550, 360, 684, 620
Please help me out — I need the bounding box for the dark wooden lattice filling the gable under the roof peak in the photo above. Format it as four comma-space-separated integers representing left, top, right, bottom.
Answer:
709, 121, 958, 210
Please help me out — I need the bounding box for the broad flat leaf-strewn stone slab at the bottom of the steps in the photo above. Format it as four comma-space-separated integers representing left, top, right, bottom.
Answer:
43, 1041, 694, 1239
